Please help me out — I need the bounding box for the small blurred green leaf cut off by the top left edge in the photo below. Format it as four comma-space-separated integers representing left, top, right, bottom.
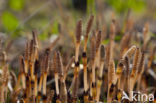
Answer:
9, 0, 24, 11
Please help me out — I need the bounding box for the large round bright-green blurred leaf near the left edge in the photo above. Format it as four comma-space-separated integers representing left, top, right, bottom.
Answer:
1, 11, 19, 31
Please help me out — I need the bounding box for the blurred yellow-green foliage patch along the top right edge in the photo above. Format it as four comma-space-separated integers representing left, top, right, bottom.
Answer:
106, 0, 146, 13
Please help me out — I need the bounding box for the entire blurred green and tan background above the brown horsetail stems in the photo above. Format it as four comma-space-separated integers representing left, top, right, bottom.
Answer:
0, 0, 156, 39
